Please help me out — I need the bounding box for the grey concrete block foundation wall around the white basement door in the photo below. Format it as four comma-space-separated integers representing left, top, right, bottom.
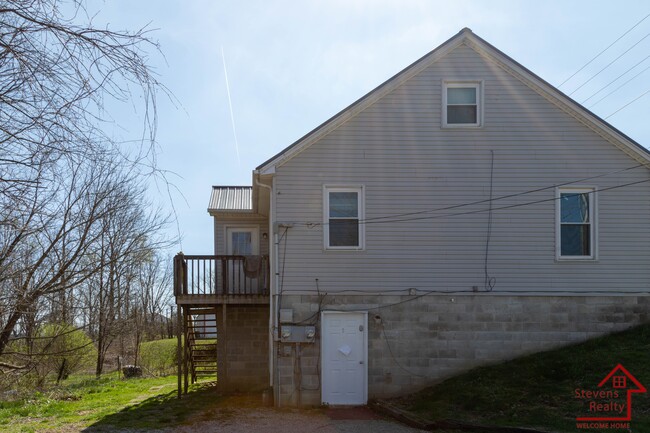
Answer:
274, 293, 650, 406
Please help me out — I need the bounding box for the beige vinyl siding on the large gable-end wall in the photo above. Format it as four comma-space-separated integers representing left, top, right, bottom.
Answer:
275, 46, 650, 293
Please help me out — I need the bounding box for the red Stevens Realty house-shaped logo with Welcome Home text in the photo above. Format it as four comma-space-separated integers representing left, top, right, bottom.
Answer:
574, 364, 646, 428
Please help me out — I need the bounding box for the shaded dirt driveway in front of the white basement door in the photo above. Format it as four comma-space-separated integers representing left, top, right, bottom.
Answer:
79, 386, 424, 433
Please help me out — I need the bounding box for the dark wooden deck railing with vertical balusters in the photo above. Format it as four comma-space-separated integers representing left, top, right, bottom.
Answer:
174, 253, 269, 296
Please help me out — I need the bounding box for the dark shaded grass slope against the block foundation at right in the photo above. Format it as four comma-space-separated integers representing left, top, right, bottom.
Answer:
396, 324, 650, 432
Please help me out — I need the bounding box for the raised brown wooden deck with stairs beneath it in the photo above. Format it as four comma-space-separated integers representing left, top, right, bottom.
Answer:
174, 253, 270, 398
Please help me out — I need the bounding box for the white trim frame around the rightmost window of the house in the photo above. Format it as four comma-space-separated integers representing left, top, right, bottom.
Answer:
555, 186, 598, 262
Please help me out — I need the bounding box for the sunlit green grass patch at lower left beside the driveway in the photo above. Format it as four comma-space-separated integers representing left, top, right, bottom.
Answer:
0, 376, 229, 433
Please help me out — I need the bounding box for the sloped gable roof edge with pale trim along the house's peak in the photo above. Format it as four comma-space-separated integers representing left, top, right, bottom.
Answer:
256, 27, 650, 174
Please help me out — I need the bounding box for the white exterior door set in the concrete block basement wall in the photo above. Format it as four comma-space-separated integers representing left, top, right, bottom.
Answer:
321, 311, 368, 405
